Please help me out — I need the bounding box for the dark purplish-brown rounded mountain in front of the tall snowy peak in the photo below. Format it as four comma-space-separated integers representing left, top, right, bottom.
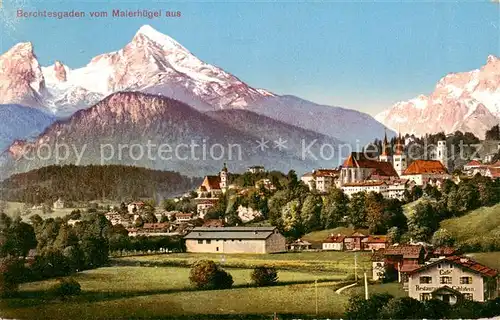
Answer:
0, 92, 332, 176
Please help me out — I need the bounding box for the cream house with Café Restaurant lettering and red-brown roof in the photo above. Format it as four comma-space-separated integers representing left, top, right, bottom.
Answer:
408, 256, 498, 304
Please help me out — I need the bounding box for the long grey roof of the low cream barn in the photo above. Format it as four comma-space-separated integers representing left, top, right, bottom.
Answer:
184, 227, 276, 240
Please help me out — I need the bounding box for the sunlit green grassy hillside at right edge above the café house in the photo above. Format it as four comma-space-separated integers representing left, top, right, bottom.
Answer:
441, 204, 500, 241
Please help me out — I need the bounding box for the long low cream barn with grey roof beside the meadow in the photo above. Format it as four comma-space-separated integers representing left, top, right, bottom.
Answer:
184, 227, 286, 253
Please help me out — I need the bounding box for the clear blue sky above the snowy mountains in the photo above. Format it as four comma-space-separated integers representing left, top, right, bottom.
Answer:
0, 0, 500, 115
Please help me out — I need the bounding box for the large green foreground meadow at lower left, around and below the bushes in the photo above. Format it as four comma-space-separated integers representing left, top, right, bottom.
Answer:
0, 267, 347, 320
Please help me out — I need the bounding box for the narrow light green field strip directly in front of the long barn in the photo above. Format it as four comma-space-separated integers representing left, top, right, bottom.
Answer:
114, 251, 371, 276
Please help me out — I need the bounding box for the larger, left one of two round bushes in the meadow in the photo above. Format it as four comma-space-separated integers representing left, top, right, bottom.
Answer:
189, 260, 233, 290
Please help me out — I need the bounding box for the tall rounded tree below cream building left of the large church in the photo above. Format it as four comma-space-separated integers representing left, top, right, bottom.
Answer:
321, 188, 349, 229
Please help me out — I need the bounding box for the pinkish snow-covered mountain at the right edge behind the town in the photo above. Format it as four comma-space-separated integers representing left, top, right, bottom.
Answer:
375, 56, 500, 138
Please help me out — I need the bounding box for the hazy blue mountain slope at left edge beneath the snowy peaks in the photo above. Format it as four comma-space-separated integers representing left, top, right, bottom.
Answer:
0, 105, 55, 153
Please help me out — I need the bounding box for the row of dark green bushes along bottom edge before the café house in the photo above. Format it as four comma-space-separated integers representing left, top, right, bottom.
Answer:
345, 293, 500, 320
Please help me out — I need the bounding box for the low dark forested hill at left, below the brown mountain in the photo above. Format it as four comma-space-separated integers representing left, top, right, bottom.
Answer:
0, 165, 201, 204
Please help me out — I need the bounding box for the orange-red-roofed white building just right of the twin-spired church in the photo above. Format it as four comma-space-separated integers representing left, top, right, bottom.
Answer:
401, 160, 451, 186
